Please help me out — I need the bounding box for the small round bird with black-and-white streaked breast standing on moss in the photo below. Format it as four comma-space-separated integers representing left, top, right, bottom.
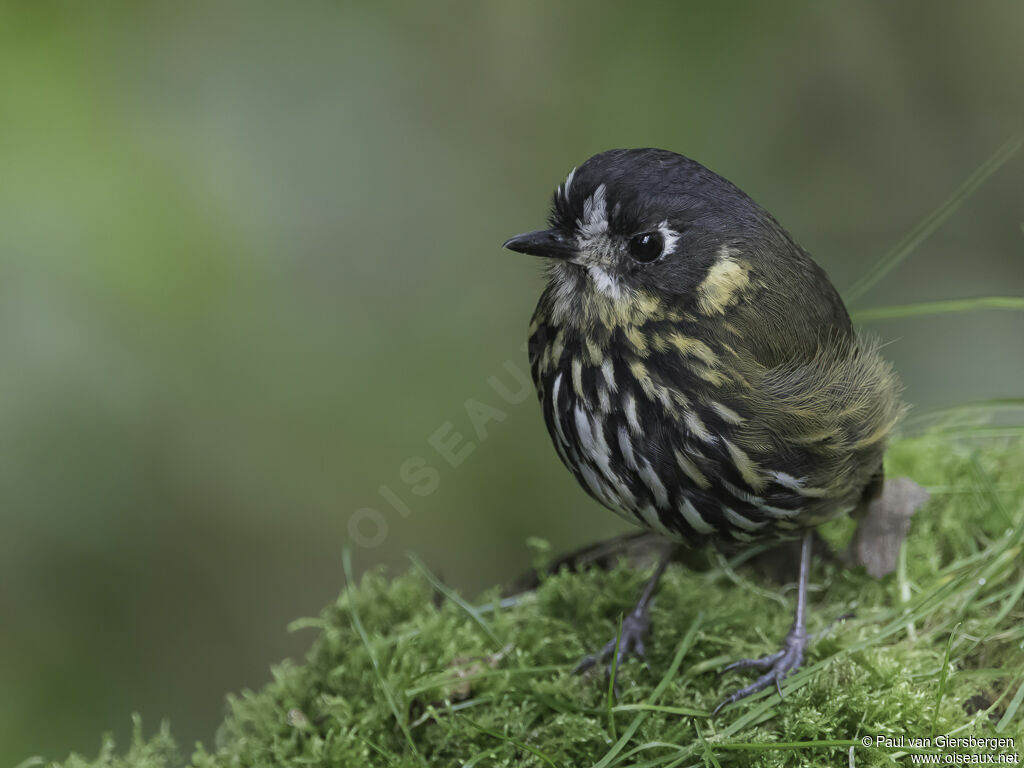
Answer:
504, 147, 904, 714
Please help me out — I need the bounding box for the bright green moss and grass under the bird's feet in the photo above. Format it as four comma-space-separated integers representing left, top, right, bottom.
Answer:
41, 433, 1024, 768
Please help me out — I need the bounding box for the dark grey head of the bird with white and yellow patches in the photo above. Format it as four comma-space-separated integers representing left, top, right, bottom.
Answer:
505, 150, 799, 325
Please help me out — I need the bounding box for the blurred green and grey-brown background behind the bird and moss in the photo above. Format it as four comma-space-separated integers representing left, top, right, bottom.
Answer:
0, 0, 1024, 765
